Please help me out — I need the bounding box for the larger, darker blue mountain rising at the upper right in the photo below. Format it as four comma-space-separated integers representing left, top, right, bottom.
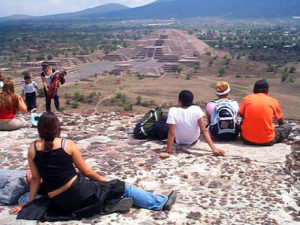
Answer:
102, 0, 300, 19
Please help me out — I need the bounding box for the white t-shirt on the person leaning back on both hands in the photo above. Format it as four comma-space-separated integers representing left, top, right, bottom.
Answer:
167, 105, 204, 145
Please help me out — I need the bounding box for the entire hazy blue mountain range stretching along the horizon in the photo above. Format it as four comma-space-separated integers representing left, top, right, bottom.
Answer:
0, 0, 300, 21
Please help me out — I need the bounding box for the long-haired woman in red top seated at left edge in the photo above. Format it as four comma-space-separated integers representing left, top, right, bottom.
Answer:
0, 80, 27, 131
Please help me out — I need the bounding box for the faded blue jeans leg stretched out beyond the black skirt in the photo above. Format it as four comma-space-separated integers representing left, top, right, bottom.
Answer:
123, 185, 168, 211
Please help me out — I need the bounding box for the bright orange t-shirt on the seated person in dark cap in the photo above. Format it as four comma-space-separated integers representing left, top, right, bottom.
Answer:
239, 93, 282, 144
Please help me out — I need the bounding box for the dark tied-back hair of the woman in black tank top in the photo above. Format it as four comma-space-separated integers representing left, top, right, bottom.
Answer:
37, 112, 61, 152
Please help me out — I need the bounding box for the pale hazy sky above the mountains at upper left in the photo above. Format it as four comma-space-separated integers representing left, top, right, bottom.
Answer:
0, 0, 155, 17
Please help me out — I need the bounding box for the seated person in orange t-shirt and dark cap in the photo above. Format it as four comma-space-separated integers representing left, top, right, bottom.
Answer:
239, 80, 292, 145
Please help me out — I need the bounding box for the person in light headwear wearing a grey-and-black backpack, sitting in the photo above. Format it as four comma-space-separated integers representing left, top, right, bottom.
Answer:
206, 81, 239, 140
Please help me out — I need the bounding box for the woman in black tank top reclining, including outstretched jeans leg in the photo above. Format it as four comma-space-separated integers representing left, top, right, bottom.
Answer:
16, 112, 176, 221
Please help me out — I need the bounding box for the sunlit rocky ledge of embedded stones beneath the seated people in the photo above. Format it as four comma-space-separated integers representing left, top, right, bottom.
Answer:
0, 113, 300, 225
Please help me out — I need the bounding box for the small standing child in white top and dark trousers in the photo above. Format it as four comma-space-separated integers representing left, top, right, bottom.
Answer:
22, 74, 38, 112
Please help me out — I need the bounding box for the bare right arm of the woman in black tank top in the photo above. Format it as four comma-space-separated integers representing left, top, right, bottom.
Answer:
65, 140, 108, 181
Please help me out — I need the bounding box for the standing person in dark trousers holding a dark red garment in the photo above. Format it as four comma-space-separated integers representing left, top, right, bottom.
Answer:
41, 62, 60, 112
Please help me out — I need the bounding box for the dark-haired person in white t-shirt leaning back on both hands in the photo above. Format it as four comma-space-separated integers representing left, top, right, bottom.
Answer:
160, 90, 225, 158
